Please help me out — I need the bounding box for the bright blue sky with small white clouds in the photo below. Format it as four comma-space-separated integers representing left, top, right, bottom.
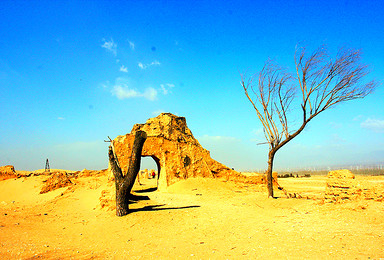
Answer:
0, 0, 384, 170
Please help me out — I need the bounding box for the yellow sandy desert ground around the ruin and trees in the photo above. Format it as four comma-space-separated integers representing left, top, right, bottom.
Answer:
0, 172, 384, 259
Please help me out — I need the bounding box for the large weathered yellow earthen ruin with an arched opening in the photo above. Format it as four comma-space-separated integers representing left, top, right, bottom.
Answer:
109, 113, 265, 190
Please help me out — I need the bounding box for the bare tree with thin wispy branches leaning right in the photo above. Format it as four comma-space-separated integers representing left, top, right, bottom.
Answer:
241, 46, 377, 197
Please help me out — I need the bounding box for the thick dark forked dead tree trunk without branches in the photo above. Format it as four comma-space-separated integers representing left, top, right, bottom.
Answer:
108, 131, 147, 216
